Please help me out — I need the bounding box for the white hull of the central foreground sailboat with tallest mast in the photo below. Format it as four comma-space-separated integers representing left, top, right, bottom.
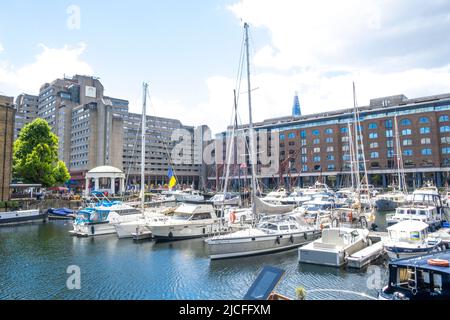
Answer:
207, 230, 321, 260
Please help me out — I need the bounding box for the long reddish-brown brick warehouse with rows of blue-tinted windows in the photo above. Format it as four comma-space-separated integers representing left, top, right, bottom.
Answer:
208, 94, 450, 188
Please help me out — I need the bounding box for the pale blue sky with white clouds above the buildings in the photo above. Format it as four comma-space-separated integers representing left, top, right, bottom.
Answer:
0, 0, 450, 133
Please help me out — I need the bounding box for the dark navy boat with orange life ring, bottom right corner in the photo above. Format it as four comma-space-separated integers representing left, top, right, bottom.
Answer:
379, 250, 450, 300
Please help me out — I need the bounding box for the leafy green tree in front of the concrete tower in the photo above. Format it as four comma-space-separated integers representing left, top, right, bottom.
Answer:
13, 118, 70, 187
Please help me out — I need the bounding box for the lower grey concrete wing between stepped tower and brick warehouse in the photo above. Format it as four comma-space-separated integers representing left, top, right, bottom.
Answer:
123, 113, 208, 187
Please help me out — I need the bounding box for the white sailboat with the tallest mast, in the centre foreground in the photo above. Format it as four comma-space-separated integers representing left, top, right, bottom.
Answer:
205, 23, 321, 259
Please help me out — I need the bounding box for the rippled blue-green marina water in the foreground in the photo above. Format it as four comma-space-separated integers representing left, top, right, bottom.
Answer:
0, 215, 387, 300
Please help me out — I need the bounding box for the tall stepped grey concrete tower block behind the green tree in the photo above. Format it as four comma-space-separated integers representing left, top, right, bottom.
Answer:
37, 75, 128, 186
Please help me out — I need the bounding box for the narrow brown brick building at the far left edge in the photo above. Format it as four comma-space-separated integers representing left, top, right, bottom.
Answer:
0, 96, 15, 201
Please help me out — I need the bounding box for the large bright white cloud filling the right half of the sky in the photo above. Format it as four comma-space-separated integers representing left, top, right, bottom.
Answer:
190, 0, 450, 132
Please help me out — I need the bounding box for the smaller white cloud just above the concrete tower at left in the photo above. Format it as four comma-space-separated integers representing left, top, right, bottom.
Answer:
0, 43, 93, 95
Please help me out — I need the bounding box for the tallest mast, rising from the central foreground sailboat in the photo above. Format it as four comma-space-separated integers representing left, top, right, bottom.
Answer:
244, 23, 256, 216
